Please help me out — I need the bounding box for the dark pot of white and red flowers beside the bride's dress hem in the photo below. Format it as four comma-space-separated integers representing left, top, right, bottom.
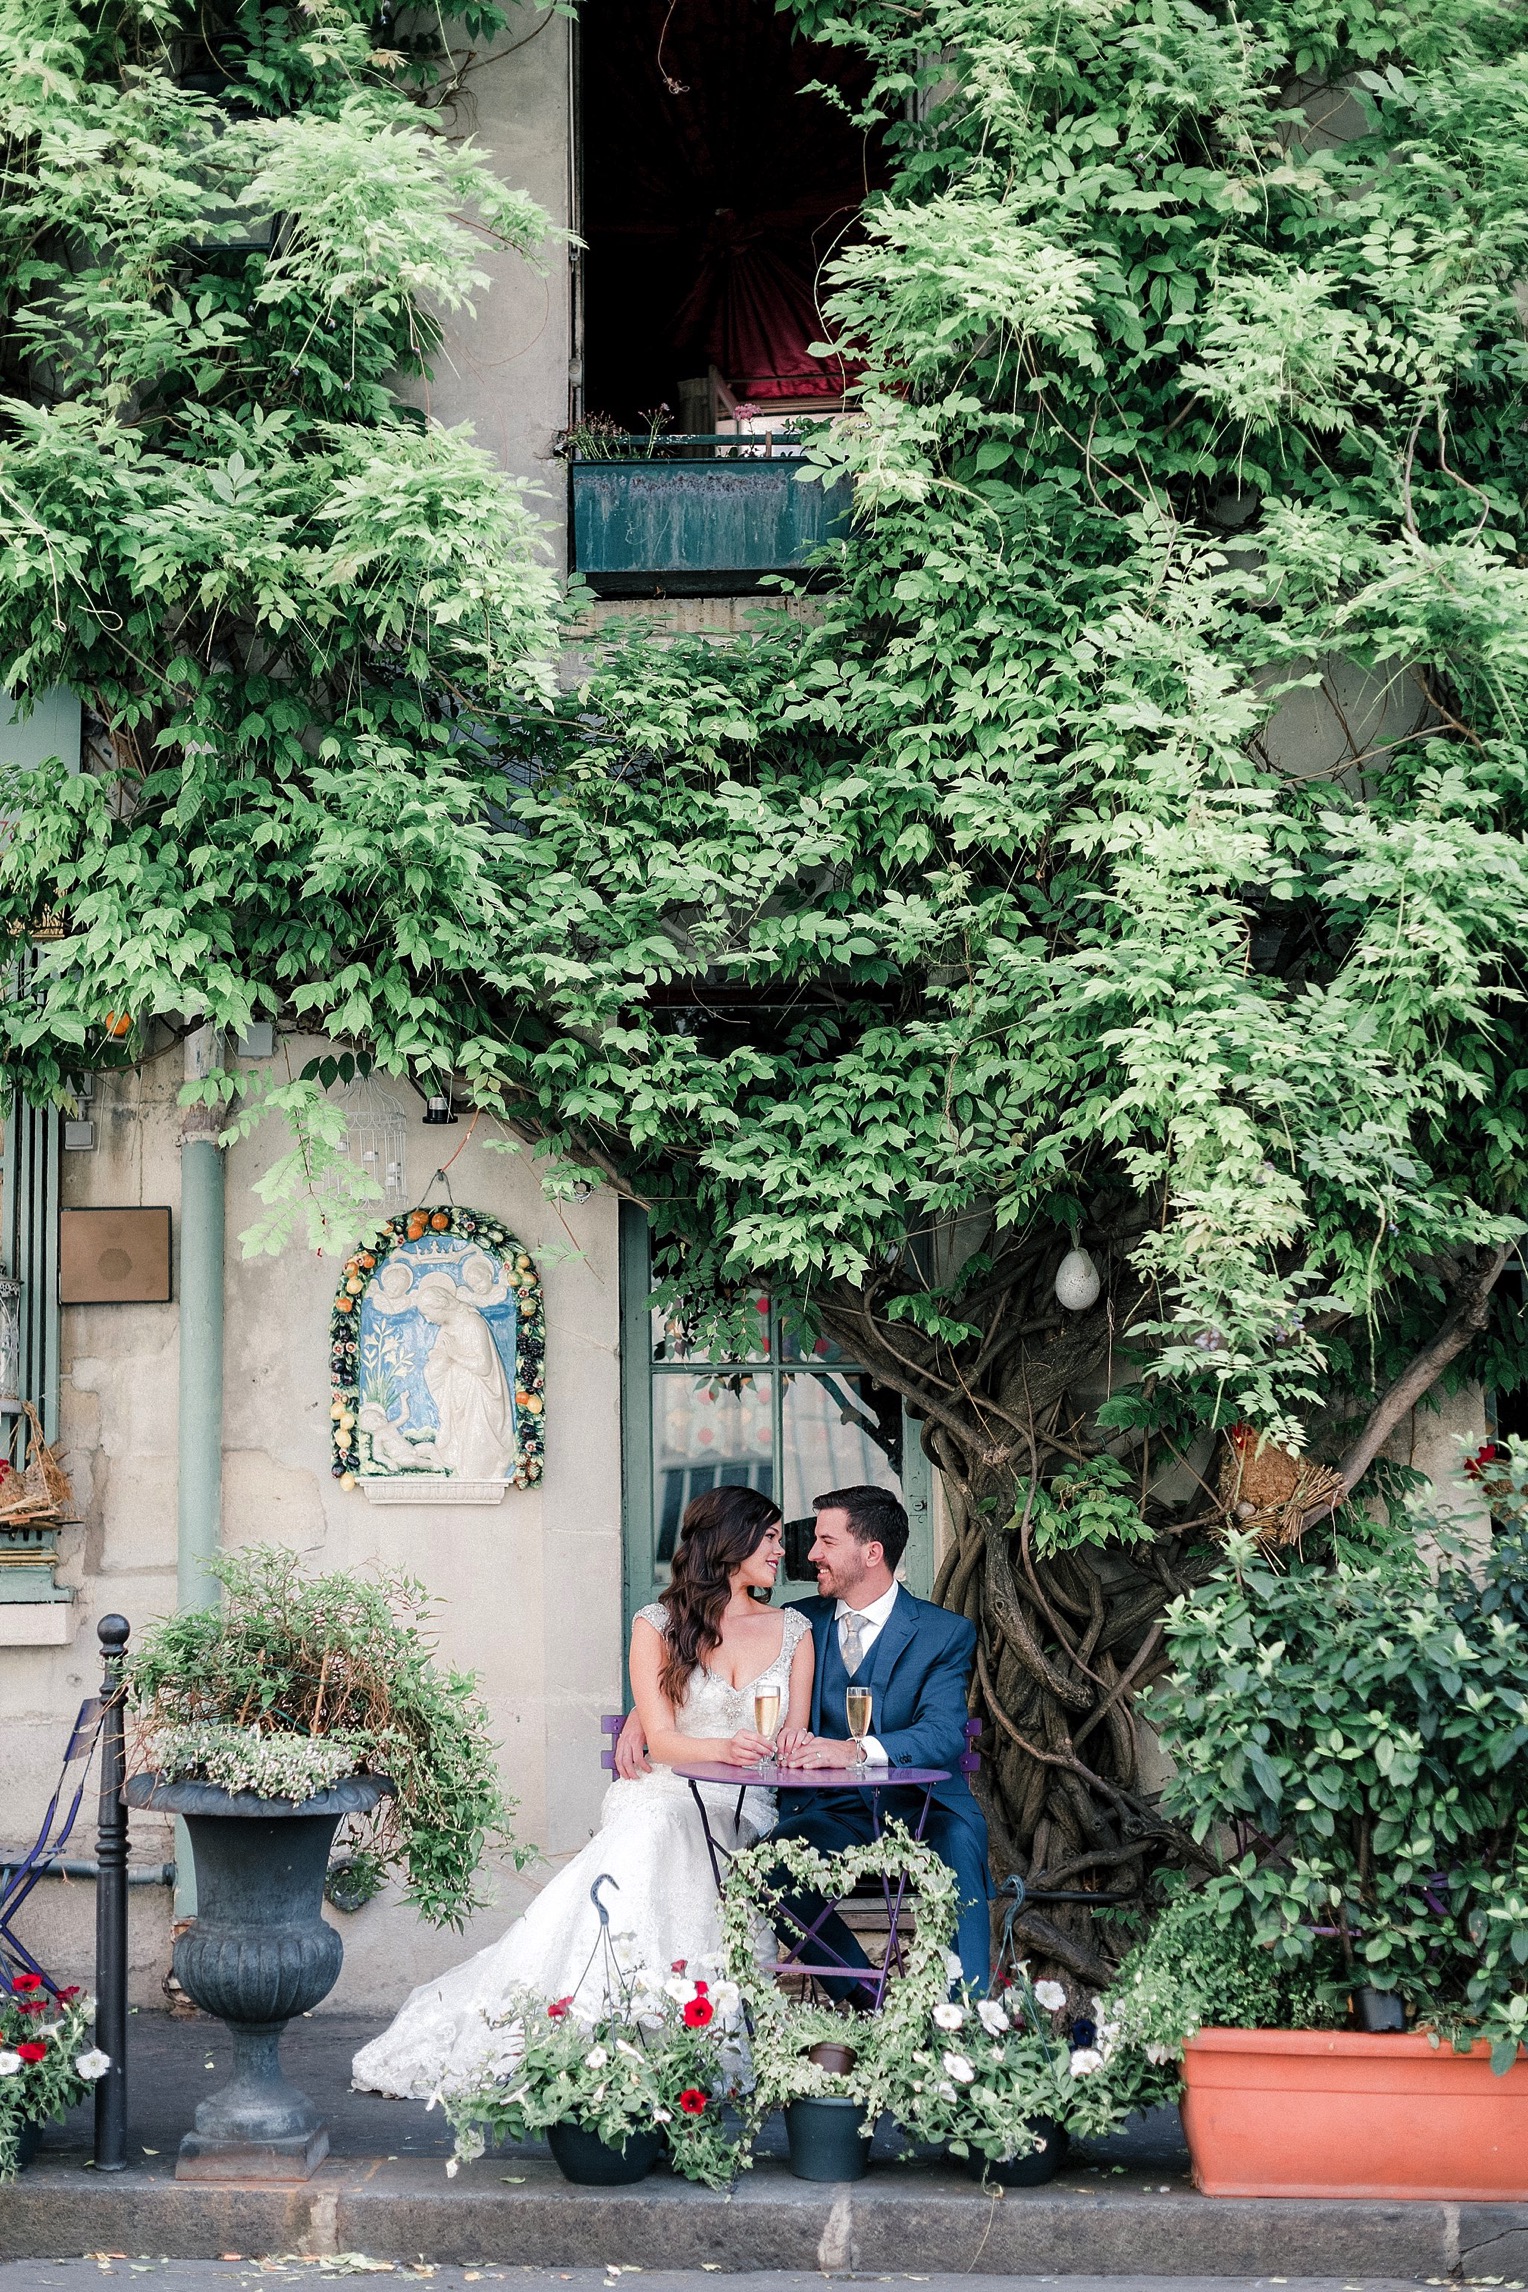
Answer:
442, 1941, 749, 2189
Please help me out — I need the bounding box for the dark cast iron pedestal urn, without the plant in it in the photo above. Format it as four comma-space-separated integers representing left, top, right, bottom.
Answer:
124, 1774, 392, 2182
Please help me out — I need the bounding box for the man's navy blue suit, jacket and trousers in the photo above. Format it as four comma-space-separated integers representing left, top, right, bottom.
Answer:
774, 1591, 992, 1989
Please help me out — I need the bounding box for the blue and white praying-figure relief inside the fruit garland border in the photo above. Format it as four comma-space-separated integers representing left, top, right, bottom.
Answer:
357, 1233, 518, 1481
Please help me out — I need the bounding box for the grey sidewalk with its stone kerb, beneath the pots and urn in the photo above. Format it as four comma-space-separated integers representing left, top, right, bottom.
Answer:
0, 2012, 1528, 2292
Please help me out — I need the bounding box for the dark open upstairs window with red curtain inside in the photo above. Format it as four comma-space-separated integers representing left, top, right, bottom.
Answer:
575, 0, 884, 438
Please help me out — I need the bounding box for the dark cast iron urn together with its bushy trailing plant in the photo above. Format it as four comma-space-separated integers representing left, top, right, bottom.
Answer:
126, 1545, 520, 2180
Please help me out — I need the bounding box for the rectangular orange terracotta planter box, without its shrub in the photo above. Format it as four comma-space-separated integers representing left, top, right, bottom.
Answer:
1182, 2028, 1528, 2200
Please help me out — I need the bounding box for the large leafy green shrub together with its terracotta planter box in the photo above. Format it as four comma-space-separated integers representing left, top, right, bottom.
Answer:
1109, 1442, 1528, 2198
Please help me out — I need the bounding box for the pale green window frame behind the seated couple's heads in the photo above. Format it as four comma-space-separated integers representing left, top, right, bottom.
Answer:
621, 1201, 935, 1636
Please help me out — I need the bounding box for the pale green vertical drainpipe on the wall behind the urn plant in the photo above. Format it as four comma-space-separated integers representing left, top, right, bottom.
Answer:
174, 1027, 222, 1918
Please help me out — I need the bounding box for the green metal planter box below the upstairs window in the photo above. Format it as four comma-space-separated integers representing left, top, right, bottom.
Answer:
568, 438, 852, 596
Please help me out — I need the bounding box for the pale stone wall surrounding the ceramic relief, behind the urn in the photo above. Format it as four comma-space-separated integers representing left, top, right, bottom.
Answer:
0, 1043, 621, 2010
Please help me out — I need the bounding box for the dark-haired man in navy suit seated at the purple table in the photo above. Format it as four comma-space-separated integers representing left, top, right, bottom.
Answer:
774, 1488, 992, 1989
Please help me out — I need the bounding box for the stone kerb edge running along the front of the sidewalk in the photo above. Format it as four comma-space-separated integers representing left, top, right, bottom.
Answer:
0, 2157, 1528, 2278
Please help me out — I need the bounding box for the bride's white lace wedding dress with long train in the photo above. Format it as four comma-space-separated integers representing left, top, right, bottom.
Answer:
351, 1604, 809, 2099
